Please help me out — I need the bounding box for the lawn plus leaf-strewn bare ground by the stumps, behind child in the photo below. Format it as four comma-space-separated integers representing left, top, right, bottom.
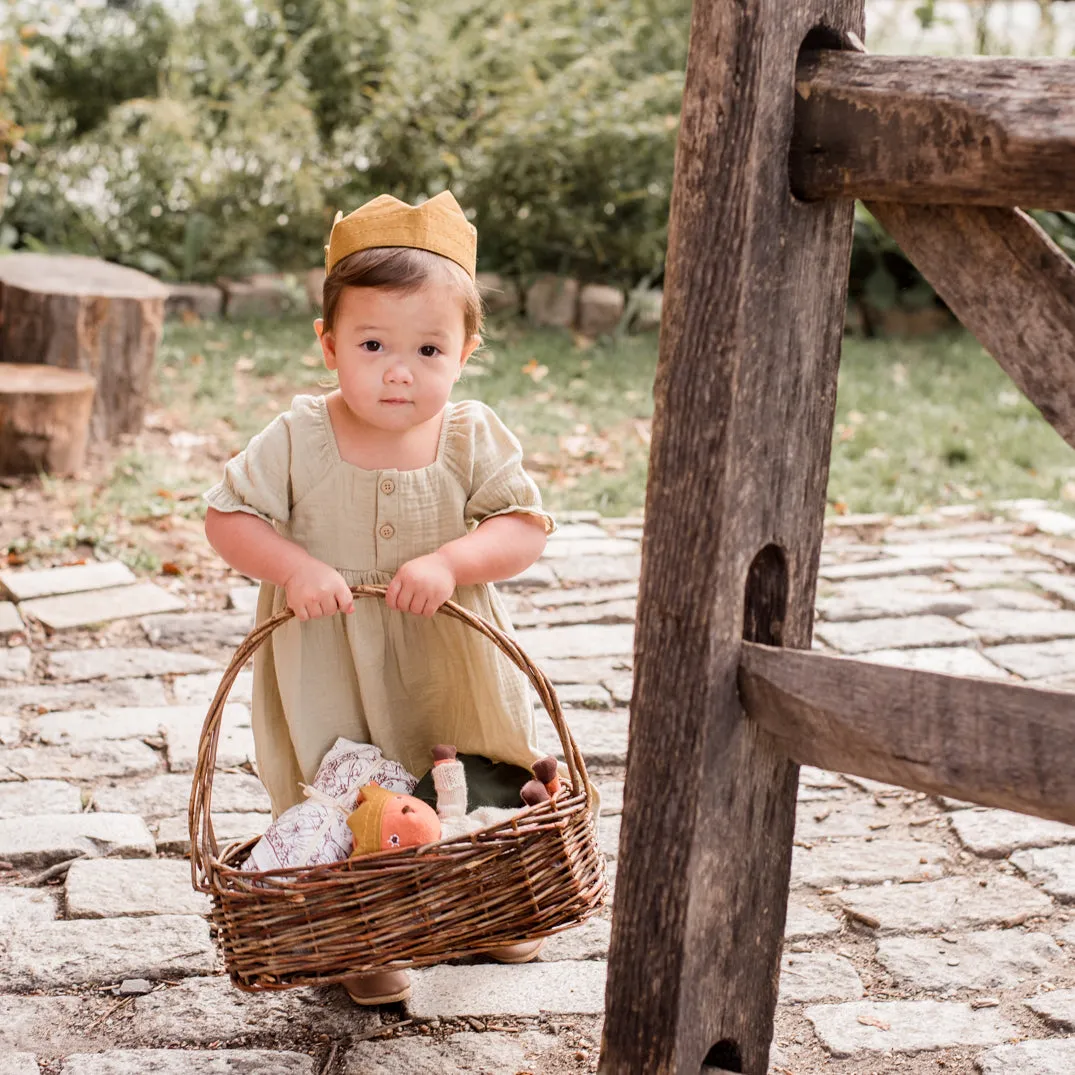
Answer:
10, 318, 1075, 573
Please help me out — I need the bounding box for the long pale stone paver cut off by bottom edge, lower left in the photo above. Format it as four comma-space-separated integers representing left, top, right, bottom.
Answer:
63, 1049, 316, 1075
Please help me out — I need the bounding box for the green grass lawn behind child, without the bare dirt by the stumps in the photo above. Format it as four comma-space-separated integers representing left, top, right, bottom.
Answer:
153, 320, 1075, 515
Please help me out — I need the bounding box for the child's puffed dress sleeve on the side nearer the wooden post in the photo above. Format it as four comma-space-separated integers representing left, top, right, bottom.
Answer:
464, 405, 556, 534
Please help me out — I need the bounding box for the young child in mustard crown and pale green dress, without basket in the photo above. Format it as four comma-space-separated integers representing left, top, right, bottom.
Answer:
205, 191, 554, 1004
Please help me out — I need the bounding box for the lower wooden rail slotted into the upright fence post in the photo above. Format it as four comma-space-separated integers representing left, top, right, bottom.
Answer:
739, 644, 1075, 825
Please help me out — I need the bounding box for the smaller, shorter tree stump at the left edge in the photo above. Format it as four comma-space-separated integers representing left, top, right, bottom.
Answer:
0, 362, 95, 474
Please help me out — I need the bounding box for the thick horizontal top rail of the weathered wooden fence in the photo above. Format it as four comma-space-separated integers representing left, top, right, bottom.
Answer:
789, 49, 1075, 209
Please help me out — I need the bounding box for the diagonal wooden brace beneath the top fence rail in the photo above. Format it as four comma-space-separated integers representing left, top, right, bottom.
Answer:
869, 202, 1075, 447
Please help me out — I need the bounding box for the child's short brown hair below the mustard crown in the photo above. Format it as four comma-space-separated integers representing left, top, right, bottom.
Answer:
321, 246, 482, 340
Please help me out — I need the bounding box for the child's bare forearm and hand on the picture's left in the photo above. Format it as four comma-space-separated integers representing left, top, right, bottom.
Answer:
205, 507, 352, 620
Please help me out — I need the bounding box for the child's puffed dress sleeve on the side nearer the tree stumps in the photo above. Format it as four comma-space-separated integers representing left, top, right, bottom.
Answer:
204, 413, 293, 522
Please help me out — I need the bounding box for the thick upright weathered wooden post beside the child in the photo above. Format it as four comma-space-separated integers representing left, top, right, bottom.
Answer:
600, 0, 862, 1075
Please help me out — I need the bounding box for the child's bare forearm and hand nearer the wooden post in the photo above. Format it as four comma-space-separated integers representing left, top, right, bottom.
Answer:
385, 512, 546, 616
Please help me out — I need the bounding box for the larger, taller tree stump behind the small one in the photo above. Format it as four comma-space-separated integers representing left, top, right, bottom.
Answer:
0, 254, 168, 441
